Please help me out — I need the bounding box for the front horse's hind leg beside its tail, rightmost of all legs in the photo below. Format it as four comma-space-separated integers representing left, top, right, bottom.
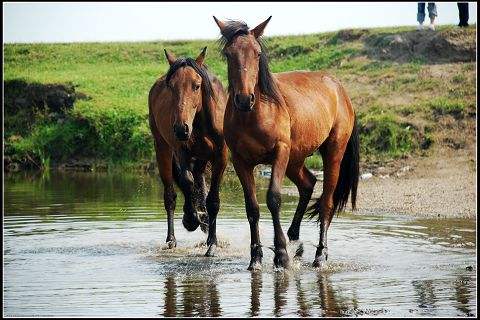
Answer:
313, 139, 346, 267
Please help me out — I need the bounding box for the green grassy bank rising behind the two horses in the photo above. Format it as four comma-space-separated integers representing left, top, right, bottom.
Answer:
4, 26, 476, 171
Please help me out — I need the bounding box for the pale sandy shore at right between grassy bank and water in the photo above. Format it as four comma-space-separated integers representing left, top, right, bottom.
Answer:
284, 150, 477, 219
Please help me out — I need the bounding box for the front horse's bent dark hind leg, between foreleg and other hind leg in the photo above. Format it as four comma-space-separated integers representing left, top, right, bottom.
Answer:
287, 164, 317, 241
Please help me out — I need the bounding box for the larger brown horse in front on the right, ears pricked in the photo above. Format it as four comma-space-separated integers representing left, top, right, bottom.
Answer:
213, 17, 359, 270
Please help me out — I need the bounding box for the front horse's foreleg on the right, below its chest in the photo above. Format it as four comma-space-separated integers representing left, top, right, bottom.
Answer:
267, 142, 290, 268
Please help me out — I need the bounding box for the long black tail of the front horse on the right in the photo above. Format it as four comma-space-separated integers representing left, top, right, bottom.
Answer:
308, 117, 360, 220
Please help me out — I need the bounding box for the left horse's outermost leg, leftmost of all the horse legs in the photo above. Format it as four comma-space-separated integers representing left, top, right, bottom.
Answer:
154, 139, 177, 249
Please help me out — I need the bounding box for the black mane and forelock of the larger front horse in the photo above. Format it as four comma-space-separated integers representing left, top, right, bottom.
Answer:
218, 20, 282, 104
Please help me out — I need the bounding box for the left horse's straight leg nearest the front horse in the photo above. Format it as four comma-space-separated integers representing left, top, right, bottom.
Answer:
205, 145, 228, 257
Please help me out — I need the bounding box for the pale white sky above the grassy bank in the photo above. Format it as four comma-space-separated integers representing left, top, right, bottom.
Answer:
3, 2, 477, 43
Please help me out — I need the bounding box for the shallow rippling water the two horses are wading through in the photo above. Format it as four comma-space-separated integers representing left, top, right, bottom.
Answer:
3, 173, 477, 317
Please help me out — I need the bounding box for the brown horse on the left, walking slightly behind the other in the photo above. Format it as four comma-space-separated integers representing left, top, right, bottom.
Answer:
148, 47, 227, 256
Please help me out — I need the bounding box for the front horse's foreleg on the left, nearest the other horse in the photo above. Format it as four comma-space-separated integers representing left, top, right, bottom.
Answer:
232, 153, 263, 270
